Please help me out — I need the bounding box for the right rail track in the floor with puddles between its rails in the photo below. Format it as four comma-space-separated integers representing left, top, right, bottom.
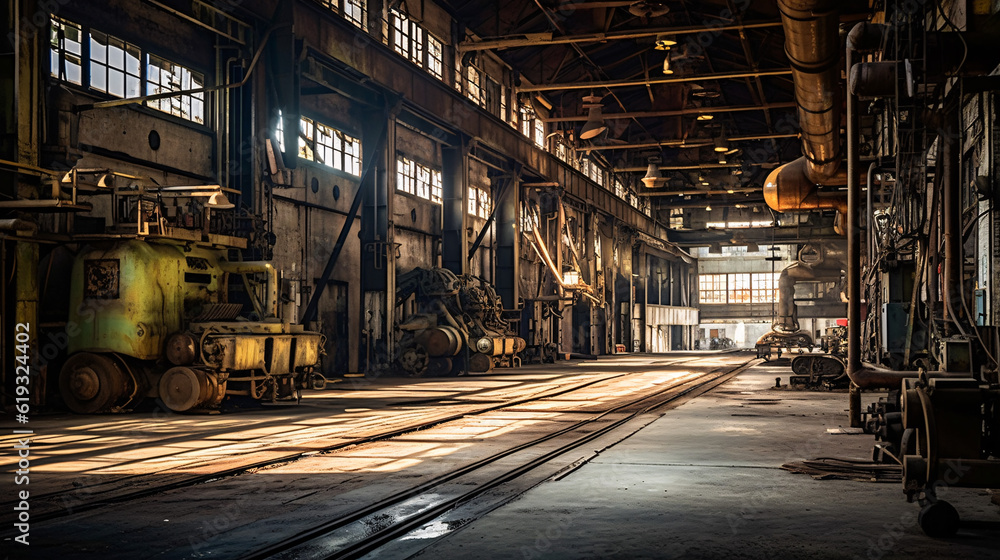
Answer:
243, 361, 756, 560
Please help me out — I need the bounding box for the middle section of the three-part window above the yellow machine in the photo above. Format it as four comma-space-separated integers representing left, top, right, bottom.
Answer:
90, 31, 142, 97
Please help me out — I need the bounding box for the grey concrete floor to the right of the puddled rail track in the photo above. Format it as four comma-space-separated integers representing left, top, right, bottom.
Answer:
406, 358, 1000, 560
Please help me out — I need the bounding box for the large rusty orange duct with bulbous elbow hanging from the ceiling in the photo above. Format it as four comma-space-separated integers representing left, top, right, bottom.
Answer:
764, 0, 847, 212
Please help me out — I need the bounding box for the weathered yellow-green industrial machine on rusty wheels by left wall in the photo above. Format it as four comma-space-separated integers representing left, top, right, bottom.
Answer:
48, 170, 324, 414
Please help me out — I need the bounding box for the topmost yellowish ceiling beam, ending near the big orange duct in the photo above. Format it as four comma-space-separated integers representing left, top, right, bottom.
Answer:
456, 21, 781, 53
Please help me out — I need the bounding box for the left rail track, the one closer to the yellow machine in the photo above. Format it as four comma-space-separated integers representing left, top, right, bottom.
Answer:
7, 357, 712, 534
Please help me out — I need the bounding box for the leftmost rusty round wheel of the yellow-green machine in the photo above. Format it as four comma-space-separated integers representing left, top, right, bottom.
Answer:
59, 352, 133, 414
